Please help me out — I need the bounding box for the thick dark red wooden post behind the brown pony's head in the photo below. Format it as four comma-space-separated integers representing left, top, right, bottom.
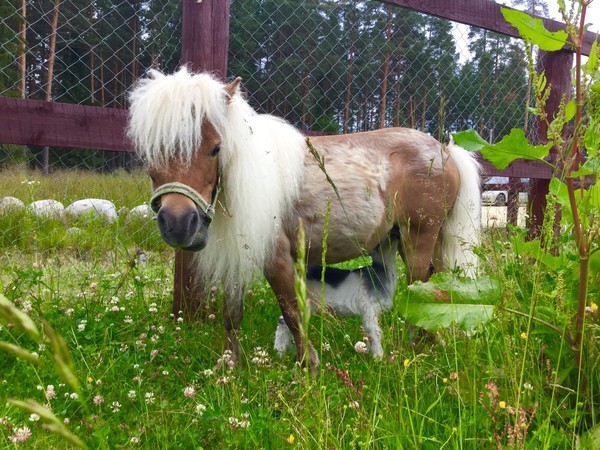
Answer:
173, 0, 229, 320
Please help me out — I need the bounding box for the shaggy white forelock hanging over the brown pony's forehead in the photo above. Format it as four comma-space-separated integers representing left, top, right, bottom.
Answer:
127, 66, 227, 167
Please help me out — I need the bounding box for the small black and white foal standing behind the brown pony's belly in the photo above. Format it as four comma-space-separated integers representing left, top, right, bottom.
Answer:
274, 227, 400, 359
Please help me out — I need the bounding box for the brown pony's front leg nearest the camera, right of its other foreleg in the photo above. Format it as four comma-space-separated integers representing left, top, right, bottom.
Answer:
265, 234, 319, 370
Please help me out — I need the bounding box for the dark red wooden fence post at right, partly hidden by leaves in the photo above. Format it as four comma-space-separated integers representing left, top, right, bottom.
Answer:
527, 50, 573, 238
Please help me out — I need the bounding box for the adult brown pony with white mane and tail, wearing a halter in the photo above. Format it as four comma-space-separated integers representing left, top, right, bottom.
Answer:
127, 66, 481, 370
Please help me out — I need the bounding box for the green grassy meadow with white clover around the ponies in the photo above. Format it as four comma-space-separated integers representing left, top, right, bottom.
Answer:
0, 170, 600, 449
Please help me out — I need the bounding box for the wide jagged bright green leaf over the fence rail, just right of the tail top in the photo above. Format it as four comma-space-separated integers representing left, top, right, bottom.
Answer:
481, 128, 552, 170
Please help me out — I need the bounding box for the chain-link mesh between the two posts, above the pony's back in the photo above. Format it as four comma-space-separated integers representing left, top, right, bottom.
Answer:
229, 0, 527, 141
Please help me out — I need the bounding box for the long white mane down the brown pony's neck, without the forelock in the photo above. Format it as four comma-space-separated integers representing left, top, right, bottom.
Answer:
196, 94, 306, 288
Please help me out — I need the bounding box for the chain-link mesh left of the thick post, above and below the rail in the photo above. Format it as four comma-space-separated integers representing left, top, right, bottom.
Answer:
0, 0, 181, 266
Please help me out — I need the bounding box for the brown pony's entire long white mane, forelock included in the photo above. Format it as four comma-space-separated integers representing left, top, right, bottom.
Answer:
128, 67, 307, 289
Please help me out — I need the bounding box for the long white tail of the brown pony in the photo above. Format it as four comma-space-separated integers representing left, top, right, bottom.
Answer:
442, 143, 481, 277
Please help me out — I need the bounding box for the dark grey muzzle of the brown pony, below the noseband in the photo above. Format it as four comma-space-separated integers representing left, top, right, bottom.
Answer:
156, 208, 210, 252
